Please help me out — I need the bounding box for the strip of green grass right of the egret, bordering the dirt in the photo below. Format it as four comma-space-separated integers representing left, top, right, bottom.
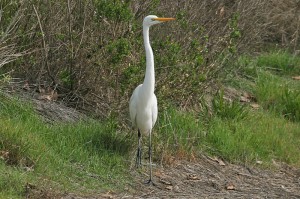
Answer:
154, 105, 300, 167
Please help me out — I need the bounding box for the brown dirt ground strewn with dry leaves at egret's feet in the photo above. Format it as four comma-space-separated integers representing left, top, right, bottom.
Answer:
62, 156, 300, 199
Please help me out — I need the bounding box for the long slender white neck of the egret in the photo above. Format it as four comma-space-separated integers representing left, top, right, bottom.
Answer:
143, 26, 155, 95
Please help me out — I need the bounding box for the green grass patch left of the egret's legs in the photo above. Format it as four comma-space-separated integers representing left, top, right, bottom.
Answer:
0, 95, 131, 198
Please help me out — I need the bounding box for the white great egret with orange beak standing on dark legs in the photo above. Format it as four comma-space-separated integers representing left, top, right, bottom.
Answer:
129, 15, 174, 184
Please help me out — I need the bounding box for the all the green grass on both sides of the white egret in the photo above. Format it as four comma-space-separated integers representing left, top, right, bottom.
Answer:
0, 51, 300, 198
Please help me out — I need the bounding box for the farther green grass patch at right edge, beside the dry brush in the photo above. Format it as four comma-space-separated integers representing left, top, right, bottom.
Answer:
230, 51, 300, 122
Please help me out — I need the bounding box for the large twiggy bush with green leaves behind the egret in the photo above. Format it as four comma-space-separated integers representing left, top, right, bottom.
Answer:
1, 0, 299, 117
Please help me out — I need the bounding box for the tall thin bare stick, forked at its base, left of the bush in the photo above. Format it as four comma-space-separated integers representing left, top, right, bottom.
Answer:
32, 5, 55, 87
